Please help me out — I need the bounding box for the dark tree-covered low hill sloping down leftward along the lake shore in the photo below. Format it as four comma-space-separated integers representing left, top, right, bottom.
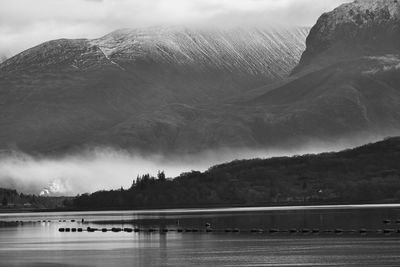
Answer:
74, 137, 400, 209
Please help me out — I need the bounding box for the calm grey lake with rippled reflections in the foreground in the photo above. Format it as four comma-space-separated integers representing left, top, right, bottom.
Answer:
0, 205, 400, 266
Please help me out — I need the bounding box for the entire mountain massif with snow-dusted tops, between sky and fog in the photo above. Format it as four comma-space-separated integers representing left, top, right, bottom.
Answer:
0, 0, 400, 157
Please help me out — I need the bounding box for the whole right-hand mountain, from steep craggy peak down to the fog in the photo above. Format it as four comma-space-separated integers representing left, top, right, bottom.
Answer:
241, 0, 400, 147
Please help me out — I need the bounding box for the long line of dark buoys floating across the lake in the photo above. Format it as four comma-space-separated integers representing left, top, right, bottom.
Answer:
58, 227, 400, 234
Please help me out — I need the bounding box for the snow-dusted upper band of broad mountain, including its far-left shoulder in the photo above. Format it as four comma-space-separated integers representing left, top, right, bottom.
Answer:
0, 27, 308, 79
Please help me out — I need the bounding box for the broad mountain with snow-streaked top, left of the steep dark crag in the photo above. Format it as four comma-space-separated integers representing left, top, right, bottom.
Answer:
0, 28, 308, 153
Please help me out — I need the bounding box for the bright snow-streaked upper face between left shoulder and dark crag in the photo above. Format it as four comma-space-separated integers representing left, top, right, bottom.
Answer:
90, 28, 308, 78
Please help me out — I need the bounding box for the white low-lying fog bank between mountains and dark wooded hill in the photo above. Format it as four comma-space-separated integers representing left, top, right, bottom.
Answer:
0, 136, 388, 196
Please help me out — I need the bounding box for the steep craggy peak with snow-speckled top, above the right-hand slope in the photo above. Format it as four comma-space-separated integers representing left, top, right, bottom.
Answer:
294, 0, 400, 72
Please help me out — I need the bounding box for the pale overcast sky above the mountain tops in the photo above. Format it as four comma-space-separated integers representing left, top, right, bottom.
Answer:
0, 0, 350, 60
